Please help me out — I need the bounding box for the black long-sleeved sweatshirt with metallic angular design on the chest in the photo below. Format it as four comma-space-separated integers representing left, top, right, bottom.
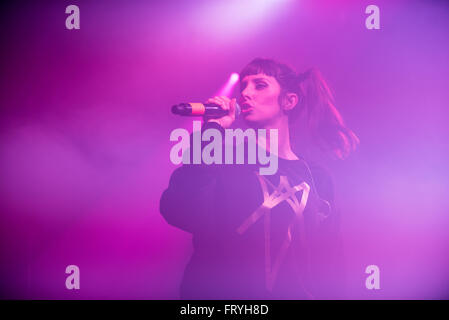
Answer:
160, 122, 341, 299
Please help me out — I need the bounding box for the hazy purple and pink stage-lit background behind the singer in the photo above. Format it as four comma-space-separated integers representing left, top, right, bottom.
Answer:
0, 0, 449, 299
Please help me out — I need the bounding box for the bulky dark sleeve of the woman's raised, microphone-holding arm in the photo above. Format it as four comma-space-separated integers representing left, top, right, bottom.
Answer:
159, 122, 224, 233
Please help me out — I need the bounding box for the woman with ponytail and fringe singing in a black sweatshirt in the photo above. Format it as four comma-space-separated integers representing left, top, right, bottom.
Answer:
160, 58, 358, 299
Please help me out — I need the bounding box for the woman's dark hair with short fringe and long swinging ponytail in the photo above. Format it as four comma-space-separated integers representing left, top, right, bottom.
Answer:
240, 58, 359, 161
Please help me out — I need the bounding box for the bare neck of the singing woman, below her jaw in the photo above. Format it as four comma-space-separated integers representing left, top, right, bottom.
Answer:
258, 116, 299, 160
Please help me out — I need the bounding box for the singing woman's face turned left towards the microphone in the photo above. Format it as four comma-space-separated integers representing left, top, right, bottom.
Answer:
239, 73, 282, 127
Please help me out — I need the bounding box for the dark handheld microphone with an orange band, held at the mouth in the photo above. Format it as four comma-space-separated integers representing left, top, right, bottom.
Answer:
171, 102, 241, 119
